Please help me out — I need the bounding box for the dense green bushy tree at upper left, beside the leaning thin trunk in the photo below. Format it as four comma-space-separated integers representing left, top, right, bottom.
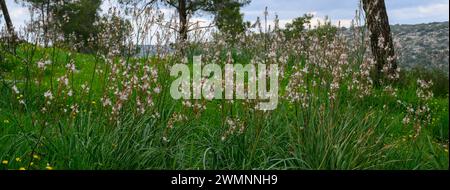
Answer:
17, 0, 102, 52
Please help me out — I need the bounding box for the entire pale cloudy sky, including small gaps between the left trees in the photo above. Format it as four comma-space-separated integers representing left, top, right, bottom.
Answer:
1, 0, 449, 27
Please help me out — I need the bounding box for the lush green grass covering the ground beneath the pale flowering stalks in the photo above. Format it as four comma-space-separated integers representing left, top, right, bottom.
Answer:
0, 46, 449, 170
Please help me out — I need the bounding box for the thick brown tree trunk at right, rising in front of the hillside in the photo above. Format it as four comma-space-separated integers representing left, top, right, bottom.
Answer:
362, 0, 397, 81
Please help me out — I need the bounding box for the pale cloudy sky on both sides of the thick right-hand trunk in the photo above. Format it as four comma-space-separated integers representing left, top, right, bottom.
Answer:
243, 0, 449, 24
